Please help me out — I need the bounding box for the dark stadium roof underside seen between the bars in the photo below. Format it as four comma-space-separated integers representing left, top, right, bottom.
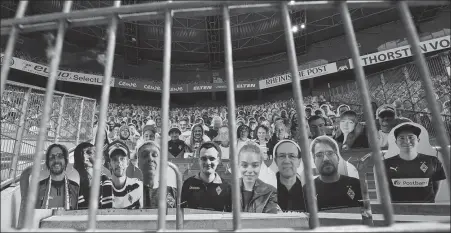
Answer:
1, 0, 449, 69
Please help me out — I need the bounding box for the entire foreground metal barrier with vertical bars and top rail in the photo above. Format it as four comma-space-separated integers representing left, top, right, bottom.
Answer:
1, 1, 451, 231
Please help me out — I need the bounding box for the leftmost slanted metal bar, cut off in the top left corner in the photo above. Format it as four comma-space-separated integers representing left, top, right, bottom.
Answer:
0, 1, 28, 97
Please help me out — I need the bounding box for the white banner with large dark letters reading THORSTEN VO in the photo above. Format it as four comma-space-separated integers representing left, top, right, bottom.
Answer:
349, 36, 451, 68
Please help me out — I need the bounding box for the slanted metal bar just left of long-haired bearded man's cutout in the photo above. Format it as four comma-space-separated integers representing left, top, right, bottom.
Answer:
25, 1, 72, 230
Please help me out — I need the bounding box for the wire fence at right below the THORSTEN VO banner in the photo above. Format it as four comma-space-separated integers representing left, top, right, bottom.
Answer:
326, 51, 451, 112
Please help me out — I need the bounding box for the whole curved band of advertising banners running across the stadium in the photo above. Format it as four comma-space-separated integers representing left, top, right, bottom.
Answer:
1, 36, 451, 93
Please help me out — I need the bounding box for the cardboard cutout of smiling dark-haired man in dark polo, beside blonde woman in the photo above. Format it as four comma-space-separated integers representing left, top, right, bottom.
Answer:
182, 142, 232, 212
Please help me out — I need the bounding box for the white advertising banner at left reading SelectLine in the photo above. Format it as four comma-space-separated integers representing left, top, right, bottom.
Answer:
1, 53, 114, 86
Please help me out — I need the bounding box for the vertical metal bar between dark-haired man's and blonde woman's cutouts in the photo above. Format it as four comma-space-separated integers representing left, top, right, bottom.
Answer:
222, 6, 241, 231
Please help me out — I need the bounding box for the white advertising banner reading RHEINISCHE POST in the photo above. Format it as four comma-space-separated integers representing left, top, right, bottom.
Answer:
260, 62, 337, 89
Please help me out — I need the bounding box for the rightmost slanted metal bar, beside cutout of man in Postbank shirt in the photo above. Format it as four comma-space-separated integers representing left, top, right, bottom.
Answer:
396, 1, 451, 190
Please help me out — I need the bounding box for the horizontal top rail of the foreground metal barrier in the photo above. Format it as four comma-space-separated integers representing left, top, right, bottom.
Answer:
0, 0, 450, 35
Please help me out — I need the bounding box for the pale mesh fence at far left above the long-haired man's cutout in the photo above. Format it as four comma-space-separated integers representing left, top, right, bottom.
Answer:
0, 81, 96, 187
